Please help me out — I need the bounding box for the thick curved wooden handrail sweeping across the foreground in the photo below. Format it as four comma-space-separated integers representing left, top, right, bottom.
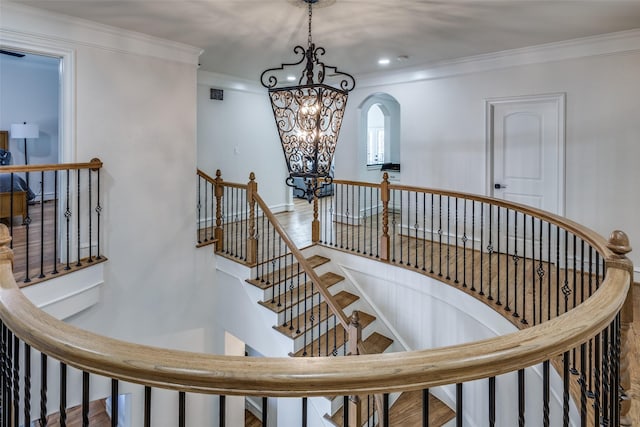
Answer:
0, 225, 631, 397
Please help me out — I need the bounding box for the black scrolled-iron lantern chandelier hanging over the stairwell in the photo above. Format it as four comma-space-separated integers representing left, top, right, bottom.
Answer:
260, 0, 356, 202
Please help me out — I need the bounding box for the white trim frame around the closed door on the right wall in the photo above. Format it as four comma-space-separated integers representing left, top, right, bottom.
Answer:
485, 92, 566, 216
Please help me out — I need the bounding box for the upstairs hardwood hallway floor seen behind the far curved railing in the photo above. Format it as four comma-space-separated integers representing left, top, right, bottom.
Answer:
277, 199, 640, 425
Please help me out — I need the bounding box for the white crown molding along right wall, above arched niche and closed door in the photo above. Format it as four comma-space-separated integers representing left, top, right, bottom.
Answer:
357, 29, 640, 88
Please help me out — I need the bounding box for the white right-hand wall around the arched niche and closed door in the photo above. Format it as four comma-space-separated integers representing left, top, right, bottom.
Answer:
336, 33, 640, 272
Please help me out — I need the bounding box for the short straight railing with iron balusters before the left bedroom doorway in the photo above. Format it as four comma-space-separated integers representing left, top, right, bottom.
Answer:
0, 159, 104, 285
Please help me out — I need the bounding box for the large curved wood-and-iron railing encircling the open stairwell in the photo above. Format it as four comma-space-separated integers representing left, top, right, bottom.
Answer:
0, 171, 633, 426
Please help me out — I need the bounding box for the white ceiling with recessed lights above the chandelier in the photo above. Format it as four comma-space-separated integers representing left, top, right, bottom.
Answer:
15, 0, 640, 81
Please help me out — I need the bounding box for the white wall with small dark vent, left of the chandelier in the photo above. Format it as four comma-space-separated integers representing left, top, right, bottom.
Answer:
198, 71, 291, 212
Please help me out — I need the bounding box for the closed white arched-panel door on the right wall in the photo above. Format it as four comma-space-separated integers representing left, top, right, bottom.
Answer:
486, 94, 565, 254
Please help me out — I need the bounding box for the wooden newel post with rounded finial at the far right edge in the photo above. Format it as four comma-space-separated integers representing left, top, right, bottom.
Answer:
607, 230, 633, 426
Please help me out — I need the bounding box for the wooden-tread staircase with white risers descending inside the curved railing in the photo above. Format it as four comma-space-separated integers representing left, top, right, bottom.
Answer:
247, 255, 455, 427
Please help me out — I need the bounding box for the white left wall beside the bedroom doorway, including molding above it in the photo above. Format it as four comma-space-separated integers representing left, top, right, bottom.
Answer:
0, 0, 215, 339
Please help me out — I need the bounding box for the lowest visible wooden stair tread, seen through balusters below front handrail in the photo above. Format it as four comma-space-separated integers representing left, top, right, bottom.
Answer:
327, 390, 456, 427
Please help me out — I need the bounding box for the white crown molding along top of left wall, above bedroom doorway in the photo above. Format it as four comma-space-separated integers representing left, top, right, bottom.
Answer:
0, 1, 202, 65
